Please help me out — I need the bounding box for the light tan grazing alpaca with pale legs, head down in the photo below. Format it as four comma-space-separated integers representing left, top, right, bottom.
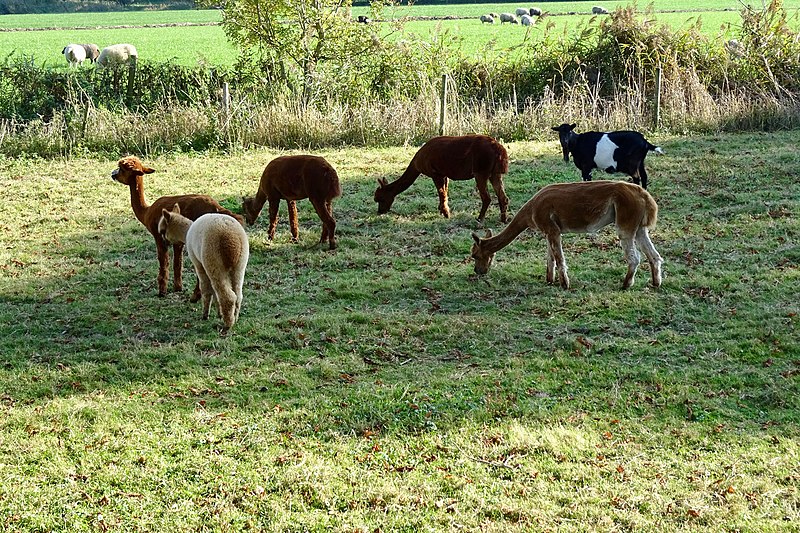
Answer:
472, 181, 662, 289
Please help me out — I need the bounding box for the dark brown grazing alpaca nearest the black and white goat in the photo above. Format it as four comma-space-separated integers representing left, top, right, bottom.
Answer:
375, 135, 508, 222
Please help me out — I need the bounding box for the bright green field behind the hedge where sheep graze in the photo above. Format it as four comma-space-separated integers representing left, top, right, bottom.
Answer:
0, 0, 800, 68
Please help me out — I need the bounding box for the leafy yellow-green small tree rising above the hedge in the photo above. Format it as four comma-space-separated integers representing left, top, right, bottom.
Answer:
206, 0, 398, 103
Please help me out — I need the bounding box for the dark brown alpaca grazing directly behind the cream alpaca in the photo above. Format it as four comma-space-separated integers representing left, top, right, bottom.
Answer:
242, 155, 342, 250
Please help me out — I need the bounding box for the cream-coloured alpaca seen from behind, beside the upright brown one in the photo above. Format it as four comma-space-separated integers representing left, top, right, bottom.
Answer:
158, 204, 250, 331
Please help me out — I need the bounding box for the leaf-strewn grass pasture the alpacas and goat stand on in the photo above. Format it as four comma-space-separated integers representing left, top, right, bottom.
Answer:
0, 132, 800, 531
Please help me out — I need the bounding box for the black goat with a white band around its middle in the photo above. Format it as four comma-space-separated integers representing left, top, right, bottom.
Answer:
553, 124, 664, 189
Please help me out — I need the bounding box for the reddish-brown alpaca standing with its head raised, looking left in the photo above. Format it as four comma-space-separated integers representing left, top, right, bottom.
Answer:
111, 156, 244, 302
